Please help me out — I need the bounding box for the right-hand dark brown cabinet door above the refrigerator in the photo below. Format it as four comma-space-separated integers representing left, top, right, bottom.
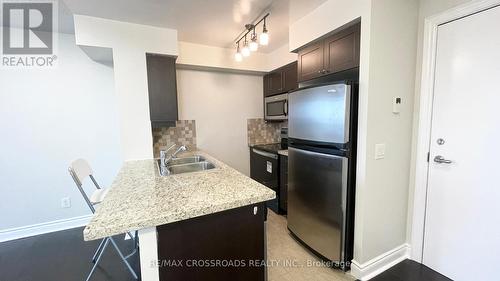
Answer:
324, 24, 360, 74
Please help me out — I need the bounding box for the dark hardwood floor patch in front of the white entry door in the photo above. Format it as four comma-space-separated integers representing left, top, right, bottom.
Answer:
370, 260, 453, 281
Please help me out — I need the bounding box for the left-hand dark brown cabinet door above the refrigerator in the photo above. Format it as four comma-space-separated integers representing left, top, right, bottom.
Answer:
298, 41, 324, 82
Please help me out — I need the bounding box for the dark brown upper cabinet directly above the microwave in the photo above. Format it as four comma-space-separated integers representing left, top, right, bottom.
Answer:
264, 61, 298, 97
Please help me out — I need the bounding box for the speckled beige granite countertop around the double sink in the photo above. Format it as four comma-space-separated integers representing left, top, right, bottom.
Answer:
83, 151, 276, 241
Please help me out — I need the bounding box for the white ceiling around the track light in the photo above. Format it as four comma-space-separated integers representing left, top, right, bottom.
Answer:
61, 0, 326, 52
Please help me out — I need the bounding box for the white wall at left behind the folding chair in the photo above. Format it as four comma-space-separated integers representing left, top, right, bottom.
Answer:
0, 34, 121, 231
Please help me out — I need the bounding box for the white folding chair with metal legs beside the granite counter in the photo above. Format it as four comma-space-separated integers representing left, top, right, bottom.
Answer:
68, 159, 139, 281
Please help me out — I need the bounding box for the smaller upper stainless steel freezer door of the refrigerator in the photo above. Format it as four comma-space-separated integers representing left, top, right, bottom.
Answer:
288, 84, 351, 144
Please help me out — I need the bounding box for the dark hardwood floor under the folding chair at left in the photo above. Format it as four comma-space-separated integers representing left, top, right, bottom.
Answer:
0, 228, 140, 281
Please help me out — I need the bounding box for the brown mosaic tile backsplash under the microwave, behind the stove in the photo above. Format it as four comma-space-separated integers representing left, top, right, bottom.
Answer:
247, 118, 288, 145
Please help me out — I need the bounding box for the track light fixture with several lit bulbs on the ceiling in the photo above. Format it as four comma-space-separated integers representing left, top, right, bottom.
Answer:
234, 13, 269, 62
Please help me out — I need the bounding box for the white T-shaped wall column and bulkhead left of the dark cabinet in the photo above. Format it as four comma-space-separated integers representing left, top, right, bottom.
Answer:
74, 15, 177, 160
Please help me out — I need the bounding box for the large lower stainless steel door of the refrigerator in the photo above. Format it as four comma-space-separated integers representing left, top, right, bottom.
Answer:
288, 147, 348, 262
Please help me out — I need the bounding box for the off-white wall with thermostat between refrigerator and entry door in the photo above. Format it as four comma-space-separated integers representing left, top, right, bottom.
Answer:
356, 0, 418, 262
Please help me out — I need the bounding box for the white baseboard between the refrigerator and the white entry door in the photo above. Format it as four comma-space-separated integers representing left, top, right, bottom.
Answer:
351, 244, 410, 281
